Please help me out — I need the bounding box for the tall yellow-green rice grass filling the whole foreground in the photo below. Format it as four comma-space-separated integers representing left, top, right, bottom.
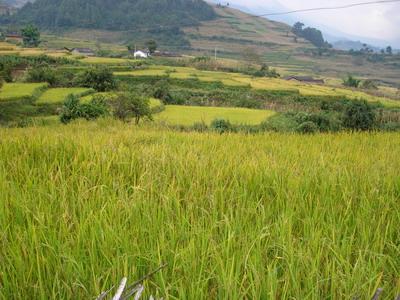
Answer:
0, 121, 400, 299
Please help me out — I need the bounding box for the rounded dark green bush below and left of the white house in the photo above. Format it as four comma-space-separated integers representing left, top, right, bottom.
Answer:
75, 67, 116, 92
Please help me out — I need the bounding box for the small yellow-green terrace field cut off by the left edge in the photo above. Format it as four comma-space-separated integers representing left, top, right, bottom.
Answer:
0, 83, 47, 101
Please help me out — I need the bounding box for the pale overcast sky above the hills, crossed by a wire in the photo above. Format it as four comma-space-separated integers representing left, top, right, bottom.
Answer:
222, 0, 400, 48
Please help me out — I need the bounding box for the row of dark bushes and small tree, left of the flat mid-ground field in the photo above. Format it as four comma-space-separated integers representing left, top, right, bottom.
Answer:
60, 91, 152, 124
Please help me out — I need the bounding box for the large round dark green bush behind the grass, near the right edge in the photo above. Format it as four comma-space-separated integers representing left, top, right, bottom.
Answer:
343, 101, 376, 130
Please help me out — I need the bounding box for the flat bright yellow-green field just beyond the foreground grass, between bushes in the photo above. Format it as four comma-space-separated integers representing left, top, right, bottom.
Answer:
154, 105, 275, 125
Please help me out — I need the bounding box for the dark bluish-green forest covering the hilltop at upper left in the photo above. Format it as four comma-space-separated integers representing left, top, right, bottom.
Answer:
2, 0, 216, 30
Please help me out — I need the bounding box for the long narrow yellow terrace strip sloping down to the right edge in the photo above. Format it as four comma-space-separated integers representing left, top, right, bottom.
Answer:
115, 66, 400, 107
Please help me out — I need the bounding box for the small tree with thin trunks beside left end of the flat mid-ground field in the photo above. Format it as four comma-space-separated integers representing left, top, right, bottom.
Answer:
112, 92, 152, 124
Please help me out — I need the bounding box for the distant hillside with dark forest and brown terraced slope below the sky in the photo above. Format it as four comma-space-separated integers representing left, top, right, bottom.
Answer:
3, 0, 400, 86
